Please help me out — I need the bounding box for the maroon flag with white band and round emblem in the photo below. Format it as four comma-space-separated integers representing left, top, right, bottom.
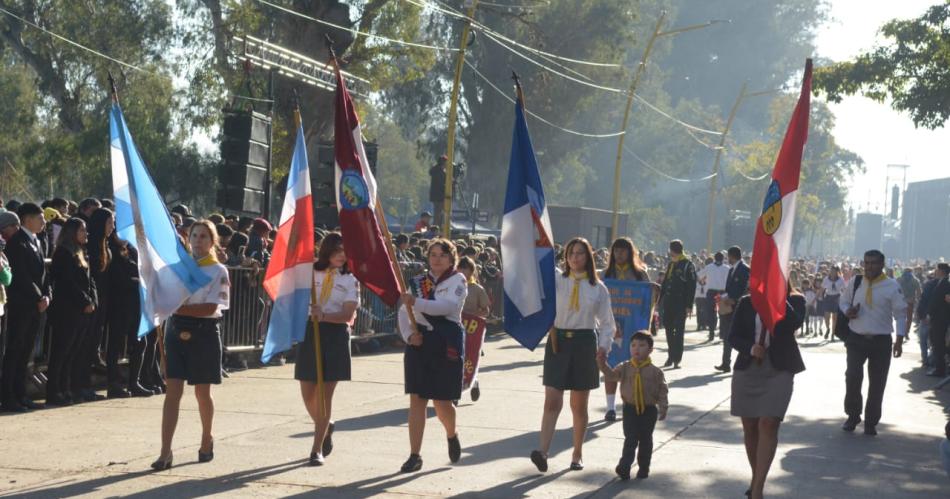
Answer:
333, 65, 400, 307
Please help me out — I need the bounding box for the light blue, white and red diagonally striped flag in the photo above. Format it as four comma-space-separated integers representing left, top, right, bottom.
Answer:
261, 115, 314, 363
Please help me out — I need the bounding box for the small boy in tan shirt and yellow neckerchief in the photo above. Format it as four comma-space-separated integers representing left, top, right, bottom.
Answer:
597, 331, 669, 480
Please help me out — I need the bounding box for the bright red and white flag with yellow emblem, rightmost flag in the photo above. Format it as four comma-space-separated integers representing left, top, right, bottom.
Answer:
749, 59, 811, 334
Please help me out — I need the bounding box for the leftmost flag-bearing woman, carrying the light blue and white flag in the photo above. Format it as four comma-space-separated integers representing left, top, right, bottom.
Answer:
152, 220, 231, 470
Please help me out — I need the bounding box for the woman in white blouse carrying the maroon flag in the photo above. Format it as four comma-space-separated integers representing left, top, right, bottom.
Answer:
399, 239, 468, 473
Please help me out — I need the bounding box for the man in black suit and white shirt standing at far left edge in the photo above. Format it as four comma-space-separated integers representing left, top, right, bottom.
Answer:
0, 203, 51, 412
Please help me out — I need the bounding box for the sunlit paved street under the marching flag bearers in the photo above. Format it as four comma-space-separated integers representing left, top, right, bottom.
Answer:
0, 331, 950, 499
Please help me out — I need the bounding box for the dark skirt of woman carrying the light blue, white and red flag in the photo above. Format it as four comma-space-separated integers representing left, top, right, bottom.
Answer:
294, 321, 352, 383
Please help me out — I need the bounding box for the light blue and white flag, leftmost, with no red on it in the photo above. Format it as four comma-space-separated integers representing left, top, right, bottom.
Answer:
109, 103, 211, 337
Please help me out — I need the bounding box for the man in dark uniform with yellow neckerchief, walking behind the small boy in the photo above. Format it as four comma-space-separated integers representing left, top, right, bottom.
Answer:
660, 239, 696, 367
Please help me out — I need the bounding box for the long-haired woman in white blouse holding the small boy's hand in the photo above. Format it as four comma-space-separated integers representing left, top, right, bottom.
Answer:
531, 237, 616, 472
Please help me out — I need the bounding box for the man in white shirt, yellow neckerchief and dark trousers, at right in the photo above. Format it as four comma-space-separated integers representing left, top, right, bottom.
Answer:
839, 250, 912, 435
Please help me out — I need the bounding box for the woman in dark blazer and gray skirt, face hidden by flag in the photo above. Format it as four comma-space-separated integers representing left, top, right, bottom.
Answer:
729, 288, 806, 499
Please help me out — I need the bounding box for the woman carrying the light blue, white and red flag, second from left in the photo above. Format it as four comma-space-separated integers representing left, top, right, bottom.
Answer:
294, 232, 360, 466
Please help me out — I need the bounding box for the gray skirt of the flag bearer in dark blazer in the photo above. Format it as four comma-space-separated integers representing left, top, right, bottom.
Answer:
730, 355, 795, 419
